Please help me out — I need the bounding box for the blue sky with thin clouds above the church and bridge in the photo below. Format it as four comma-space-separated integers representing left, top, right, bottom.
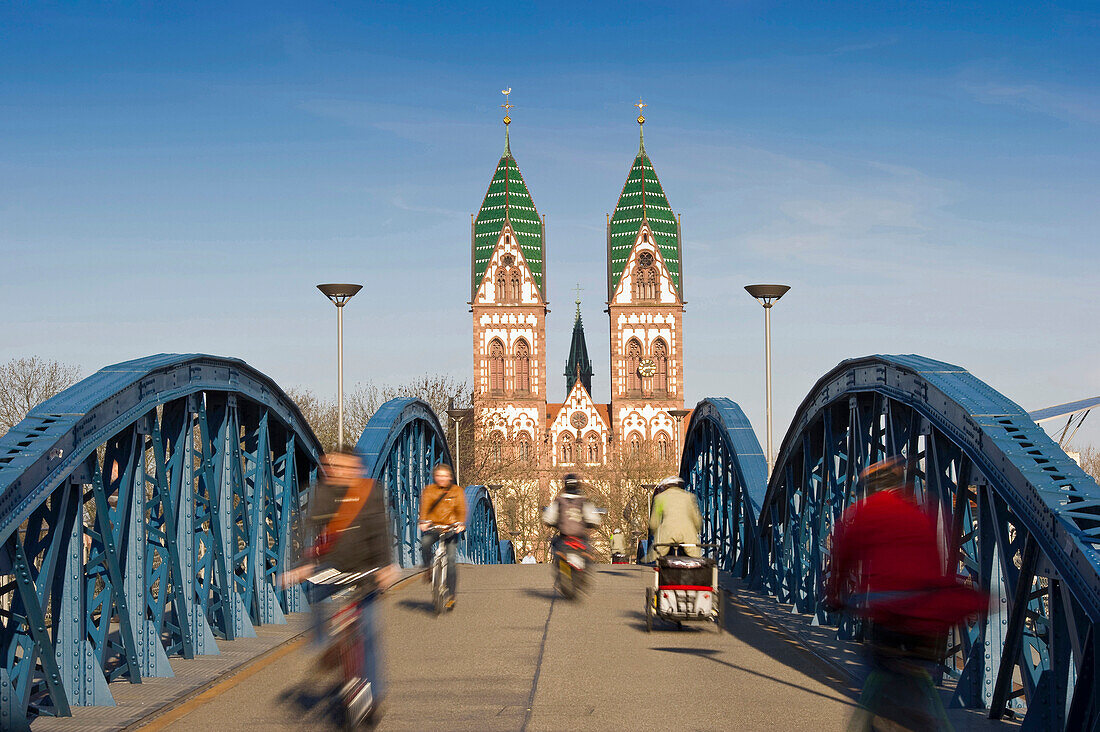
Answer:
0, 1, 1100, 444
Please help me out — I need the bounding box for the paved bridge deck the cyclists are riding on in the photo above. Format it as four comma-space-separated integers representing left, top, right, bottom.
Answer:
141, 565, 855, 731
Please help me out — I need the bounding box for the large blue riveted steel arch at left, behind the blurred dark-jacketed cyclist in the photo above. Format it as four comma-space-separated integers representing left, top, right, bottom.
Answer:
0, 354, 320, 729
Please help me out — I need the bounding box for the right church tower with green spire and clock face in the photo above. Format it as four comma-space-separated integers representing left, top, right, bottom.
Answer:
607, 101, 684, 456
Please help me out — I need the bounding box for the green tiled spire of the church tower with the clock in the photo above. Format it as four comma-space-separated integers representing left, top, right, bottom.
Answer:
607, 126, 683, 299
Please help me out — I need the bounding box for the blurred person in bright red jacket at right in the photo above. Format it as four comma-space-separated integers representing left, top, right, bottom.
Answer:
825, 458, 989, 730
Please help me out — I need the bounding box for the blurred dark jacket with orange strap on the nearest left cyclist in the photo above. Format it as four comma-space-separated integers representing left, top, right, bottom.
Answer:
310, 478, 393, 585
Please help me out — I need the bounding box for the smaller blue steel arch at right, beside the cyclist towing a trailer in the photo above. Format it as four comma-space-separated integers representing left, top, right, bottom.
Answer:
677, 397, 768, 576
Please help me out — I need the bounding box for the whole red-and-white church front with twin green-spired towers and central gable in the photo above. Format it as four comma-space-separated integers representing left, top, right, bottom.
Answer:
470, 116, 684, 478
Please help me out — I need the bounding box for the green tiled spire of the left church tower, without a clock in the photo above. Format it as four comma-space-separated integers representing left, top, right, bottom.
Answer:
471, 128, 546, 301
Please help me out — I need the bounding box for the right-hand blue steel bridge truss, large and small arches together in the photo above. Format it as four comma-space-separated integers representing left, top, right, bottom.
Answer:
681, 356, 1100, 729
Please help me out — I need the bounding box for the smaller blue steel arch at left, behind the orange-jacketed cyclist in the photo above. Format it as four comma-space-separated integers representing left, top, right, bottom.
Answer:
355, 398, 451, 567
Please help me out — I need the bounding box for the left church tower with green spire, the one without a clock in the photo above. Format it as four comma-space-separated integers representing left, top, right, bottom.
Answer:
470, 94, 547, 457
